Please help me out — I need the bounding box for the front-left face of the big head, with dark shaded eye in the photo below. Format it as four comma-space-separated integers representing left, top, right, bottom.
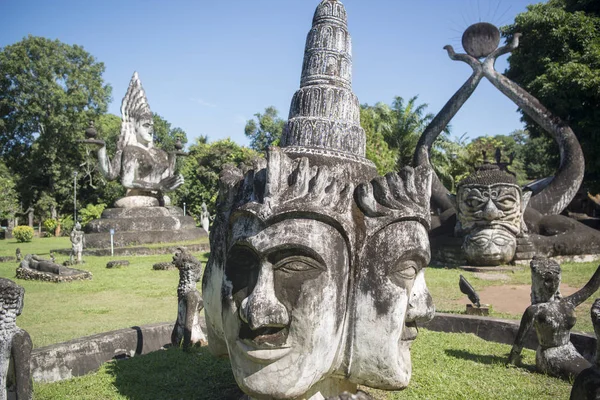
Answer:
223, 216, 349, 398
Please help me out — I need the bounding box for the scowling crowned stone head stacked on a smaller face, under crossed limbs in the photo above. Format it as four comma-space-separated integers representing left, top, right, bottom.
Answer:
455, 154, 531, 265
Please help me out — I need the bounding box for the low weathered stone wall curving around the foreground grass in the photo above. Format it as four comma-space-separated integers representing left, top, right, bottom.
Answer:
31, 313, 596, 382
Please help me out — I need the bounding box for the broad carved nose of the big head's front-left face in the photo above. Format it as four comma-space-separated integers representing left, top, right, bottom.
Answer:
240, 264, 290, 330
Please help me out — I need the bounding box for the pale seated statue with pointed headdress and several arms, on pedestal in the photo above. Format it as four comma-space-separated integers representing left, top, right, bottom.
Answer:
86, 72, 183, 208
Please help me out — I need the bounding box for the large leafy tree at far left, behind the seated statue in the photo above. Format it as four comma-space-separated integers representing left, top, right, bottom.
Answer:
0, 36, 111, 217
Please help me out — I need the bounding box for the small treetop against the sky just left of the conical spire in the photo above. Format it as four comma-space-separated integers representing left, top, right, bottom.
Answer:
244, 106, 285, 153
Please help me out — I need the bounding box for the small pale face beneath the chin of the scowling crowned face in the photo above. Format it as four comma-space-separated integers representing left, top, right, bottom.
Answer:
463, 228, 517, 265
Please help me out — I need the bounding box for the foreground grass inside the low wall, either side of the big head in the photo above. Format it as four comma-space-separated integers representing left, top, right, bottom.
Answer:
35, 330, 571, 400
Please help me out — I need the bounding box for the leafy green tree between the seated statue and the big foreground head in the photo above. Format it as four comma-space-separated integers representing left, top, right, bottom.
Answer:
175, 136, 259, 218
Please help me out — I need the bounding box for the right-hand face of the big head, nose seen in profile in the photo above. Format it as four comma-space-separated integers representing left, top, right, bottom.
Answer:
350, 221, 434, 390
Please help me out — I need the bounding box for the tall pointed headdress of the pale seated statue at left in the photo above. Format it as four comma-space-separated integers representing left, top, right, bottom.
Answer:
121, 71, 152, 144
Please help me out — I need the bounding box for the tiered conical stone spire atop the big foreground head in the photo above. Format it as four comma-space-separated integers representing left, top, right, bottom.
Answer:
281, 0, 372, 166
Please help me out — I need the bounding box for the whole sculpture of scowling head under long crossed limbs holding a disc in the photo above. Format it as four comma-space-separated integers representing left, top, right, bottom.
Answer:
414, 23, 600, 265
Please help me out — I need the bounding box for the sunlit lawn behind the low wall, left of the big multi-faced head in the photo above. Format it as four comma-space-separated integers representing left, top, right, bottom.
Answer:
0, 238, 206, 347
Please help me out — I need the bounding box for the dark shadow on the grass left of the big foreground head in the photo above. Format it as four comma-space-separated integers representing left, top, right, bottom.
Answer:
107, 348, 243, 400
